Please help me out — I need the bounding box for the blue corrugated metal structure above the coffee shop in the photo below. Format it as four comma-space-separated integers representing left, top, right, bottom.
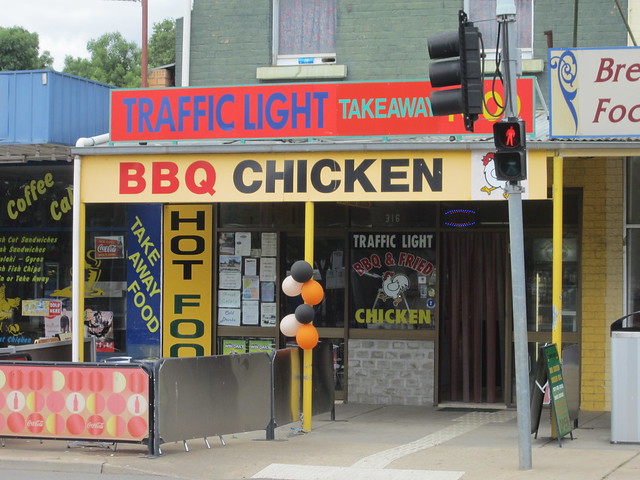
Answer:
0, 70, 112, 146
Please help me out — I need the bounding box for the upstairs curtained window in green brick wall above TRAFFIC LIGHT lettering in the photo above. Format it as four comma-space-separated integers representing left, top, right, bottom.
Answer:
273, 0, 337, 65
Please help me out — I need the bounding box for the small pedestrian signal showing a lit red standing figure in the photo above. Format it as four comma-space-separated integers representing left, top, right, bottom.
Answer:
493, 119, 527, 181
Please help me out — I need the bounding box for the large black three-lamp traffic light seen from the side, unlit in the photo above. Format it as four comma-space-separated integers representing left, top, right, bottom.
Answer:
427, 10, 484, 132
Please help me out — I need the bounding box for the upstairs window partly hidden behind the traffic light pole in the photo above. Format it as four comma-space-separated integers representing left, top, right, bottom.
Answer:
464, 0, 534, 60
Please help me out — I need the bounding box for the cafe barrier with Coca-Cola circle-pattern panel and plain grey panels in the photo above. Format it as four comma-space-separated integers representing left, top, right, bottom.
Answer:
0, 342, 335, 455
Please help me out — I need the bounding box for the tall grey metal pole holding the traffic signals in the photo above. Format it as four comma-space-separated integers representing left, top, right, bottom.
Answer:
496, 2, 532, 470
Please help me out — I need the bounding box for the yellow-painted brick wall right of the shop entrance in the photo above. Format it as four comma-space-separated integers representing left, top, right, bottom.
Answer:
564, 157, 624, 410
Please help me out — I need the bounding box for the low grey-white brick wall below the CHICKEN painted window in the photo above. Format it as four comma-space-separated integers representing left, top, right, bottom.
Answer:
348, 339, 435, 406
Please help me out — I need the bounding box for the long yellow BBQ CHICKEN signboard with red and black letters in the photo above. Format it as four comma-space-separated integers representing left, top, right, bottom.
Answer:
81, 150, 547, 203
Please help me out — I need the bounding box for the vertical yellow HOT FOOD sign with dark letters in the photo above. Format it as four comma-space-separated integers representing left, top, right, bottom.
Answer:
162, 205, 213, 357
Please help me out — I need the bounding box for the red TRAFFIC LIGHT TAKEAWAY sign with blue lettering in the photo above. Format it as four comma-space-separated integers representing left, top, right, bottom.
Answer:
111, 78, 534, 142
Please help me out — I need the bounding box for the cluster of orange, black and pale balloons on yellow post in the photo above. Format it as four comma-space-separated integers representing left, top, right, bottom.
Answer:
280, 260, 324, 350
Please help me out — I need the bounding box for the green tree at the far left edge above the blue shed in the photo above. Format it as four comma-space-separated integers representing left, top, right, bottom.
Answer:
0, 27, 53, 71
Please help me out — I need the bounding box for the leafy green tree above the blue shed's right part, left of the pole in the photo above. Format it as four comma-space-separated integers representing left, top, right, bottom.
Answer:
63, 32, 141, 88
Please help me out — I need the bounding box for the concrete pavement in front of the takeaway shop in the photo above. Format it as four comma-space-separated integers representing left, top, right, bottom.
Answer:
0, 404, 640, 480
